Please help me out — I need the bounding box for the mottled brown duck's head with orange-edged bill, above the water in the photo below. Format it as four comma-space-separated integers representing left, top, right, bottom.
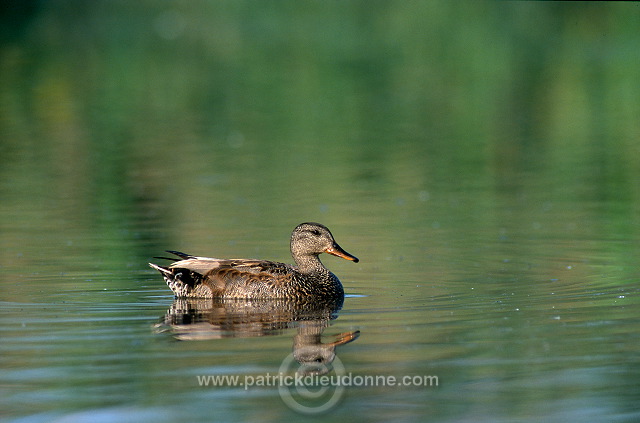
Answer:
291, 222, 359, 263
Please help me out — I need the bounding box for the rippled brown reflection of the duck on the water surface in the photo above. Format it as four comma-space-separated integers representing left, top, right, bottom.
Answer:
155, 298, 360, 372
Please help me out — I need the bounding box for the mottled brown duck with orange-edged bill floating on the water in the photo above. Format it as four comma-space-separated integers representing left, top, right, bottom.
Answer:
149, 222, 359, 300
